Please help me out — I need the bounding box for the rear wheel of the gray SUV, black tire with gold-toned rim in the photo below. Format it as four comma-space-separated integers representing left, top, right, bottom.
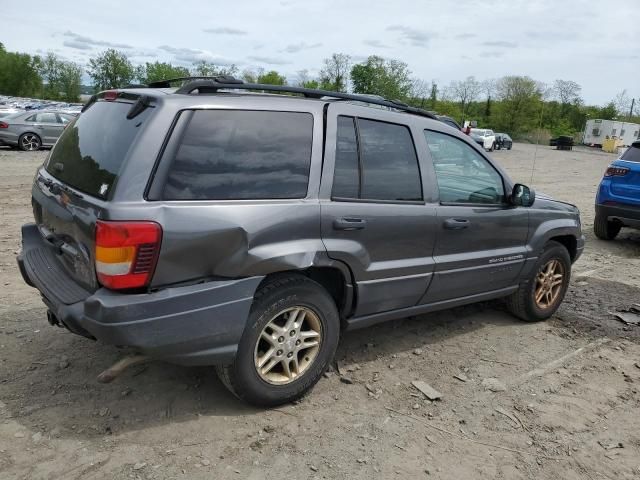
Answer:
217, 275, 340, 407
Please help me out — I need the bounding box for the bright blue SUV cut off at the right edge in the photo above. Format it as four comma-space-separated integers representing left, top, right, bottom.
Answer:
593, 141, 640, 240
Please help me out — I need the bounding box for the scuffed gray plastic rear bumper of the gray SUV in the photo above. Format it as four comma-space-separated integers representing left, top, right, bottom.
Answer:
18, 224, 263, 365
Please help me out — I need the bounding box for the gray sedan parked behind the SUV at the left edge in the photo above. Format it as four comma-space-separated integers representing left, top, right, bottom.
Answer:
0, 110, 75, 150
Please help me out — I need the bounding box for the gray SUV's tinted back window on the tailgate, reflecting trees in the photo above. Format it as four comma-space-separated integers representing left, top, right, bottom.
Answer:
46, 102, 152, 198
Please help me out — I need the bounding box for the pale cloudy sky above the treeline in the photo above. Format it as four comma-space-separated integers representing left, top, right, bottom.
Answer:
0, 0, 640, 105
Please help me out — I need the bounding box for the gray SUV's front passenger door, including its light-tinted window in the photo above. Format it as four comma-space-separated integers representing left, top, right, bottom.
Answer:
420, 130, 529, 303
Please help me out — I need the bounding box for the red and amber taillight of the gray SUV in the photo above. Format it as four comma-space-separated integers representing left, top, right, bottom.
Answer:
95, 220, 162, 290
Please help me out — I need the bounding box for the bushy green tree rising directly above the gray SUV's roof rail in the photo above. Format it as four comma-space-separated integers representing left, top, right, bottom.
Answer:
351, 55, 413, 100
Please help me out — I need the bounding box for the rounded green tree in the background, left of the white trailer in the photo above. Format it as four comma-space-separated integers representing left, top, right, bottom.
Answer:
493, 76, 541, 135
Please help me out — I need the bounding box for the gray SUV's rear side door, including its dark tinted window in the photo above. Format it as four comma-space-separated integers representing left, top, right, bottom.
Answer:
320, 104, 435, 316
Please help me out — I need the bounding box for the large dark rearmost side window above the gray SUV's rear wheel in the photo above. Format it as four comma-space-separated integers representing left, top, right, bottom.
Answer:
163, 110, 313, 200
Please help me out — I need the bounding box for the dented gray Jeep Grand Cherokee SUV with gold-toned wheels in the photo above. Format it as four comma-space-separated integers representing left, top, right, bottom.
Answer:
18, 77, 584, 406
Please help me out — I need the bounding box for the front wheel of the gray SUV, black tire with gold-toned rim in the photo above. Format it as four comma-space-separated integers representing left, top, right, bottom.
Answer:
507, 241, 571, 322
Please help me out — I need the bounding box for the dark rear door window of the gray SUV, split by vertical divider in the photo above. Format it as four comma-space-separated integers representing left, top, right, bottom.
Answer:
333, 117, 423, 201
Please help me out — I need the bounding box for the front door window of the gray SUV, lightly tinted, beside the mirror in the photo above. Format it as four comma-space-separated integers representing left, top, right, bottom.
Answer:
424, 130, 505, 204
